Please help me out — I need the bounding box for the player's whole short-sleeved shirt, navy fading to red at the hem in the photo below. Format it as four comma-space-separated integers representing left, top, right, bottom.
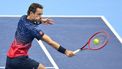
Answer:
7, 15, 44, 58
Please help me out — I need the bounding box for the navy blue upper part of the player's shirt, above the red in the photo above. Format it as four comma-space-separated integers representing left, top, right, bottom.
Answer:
15, 15, 43, 43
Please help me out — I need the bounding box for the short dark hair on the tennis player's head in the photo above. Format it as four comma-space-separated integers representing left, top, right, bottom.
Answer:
27, 3, 43, 15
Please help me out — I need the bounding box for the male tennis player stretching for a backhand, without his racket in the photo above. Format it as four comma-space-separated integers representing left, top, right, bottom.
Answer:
5, 3, 74, 69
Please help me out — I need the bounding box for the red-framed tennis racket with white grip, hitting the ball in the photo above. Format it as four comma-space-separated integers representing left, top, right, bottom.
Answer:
73, 31, 109, 54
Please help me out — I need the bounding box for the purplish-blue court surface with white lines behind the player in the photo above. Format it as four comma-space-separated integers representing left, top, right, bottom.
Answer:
0, 16, 122, 69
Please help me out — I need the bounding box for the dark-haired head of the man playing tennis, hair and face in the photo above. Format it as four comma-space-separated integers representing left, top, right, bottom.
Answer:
27, 3, 43, 21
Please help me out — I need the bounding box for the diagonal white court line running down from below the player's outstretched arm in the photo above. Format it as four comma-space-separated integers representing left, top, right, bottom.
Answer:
37, 40, 59, 69
